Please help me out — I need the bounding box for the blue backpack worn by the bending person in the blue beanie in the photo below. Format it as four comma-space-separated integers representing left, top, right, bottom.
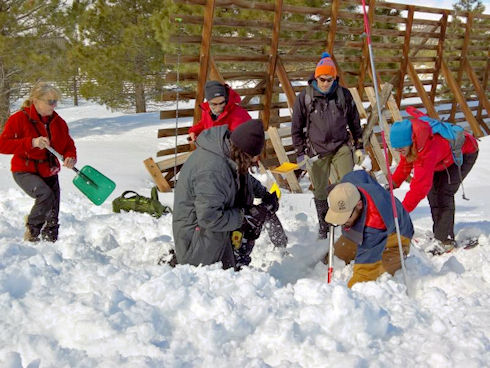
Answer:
406, 106, 466, 167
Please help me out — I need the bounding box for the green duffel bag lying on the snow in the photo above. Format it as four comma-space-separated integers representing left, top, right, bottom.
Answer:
112, 187, 172, 218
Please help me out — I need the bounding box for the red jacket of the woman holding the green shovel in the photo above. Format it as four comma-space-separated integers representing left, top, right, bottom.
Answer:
0, 105, 77, 177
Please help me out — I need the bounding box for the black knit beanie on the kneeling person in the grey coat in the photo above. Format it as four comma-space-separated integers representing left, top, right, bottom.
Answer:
230, 119, 265, 156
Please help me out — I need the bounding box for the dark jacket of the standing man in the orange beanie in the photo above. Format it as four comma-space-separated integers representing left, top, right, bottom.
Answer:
291, 79, 362, 156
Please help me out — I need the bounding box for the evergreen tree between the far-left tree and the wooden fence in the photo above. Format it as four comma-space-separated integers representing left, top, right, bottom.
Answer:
77, 0, 163, 112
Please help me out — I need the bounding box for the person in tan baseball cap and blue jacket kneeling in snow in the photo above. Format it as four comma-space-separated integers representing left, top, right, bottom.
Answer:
325, 170, 414, 287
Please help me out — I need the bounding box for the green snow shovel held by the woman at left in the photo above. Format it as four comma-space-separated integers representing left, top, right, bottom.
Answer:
46, 147, 116, 206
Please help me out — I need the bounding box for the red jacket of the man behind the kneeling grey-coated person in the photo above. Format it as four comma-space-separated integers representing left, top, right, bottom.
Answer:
189, 85, 251, 136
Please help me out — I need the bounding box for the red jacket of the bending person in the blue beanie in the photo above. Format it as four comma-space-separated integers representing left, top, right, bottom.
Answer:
393, 119, 478, 212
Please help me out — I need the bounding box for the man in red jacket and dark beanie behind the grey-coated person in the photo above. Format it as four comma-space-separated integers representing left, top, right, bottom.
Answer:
189, 81, 251, 142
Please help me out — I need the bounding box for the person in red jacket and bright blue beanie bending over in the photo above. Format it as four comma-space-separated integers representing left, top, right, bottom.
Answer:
390, 118, 478, 252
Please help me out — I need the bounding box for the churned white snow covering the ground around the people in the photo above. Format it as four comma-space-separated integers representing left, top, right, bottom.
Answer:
0, 103, 490, 368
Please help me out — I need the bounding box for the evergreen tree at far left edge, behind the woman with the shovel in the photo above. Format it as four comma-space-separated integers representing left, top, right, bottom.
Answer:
0, 0, 64, 130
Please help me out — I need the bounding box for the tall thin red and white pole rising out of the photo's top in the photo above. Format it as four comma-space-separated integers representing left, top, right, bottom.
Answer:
362, 0, 408, 292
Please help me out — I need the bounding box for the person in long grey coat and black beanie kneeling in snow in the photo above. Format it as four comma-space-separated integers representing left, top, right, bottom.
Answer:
172, 119, 279, 269
